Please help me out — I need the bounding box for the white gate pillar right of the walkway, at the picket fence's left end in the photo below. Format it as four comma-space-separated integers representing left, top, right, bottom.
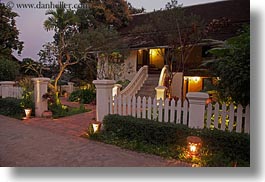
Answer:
93, 80, 115, 122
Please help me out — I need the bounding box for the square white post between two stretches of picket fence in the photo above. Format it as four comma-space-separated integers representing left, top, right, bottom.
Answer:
186, 92, 209, 128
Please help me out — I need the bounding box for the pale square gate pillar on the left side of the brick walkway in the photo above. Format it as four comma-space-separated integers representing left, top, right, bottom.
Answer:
32, 78, 50, 117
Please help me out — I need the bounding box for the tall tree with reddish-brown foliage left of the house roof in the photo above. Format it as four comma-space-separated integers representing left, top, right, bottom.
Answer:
77, 0, 132, 79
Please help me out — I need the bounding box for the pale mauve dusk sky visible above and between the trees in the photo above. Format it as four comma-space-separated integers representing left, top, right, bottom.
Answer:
3, 0, 224, 60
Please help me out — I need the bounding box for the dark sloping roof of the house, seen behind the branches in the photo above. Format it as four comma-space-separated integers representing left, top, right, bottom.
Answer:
120, 0, 250, 49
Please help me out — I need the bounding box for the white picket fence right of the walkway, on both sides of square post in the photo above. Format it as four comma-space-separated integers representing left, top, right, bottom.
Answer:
109, 96, 250, 133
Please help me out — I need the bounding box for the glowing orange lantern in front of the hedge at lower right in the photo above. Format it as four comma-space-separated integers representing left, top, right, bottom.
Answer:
187, 136, 202, 156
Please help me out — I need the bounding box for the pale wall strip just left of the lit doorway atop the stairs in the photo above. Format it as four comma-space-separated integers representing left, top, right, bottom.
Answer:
124, 50, 137, 81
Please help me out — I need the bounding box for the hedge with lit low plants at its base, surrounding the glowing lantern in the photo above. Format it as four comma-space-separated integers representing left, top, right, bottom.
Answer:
100, 115, 250, 167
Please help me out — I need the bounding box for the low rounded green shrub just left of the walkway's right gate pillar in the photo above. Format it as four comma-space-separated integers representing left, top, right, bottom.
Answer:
69, 89, 96, 104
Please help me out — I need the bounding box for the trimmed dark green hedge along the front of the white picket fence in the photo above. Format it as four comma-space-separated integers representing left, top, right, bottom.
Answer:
103, 115, 250, 166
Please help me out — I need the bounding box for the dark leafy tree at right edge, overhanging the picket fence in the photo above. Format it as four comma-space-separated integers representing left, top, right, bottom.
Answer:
205, 26, 250, 106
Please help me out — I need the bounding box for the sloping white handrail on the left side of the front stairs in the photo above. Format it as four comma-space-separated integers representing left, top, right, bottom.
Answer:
120, 66, 148, 96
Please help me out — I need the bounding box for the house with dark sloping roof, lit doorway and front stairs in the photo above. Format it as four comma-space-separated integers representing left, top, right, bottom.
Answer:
98, 0, 250, 97
